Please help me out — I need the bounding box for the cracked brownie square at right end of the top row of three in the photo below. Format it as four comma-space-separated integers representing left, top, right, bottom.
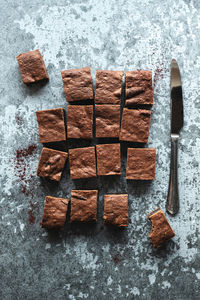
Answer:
126, 70, 153, 106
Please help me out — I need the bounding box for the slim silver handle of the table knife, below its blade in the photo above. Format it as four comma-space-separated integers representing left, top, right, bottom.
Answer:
166, 135, 179, 215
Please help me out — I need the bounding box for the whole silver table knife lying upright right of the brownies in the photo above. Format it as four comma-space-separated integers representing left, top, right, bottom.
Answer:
166, 59, 183, 215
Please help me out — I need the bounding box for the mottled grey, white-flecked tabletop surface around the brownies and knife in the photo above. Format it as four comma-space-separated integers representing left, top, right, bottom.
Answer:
0, 0, 200, 300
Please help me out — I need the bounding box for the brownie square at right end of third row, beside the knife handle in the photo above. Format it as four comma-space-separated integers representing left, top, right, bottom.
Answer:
126, 148, 156, 180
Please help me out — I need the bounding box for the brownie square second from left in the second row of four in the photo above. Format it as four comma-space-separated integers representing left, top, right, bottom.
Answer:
67, 105, 93, 139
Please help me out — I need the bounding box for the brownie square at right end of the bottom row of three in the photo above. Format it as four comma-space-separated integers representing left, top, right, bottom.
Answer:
103, 194, 128, 227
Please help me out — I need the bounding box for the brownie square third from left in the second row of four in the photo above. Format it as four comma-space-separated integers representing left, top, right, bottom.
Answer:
95, 105, 120, 138
